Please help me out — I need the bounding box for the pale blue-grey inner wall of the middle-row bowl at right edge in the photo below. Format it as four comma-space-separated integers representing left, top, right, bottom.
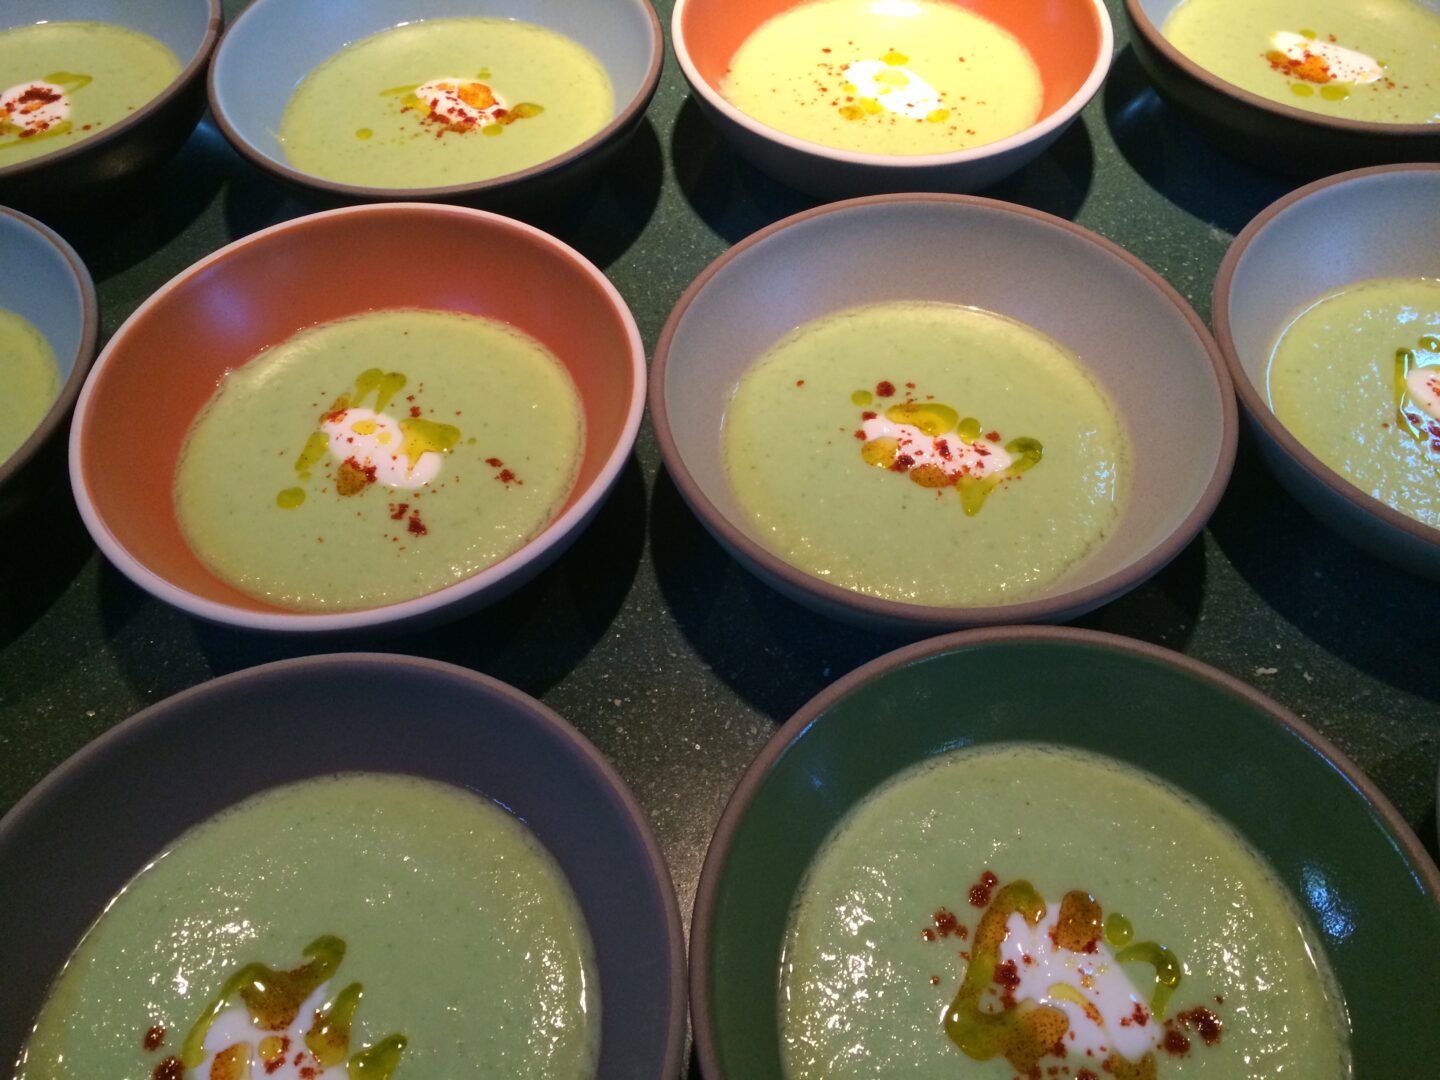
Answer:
1225, 168, 1440, 408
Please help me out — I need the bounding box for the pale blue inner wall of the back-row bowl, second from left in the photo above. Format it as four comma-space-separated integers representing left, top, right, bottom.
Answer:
212, 0, 658, 180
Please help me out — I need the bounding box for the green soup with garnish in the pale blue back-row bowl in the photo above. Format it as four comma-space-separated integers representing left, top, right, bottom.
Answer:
279, 19, 615, 187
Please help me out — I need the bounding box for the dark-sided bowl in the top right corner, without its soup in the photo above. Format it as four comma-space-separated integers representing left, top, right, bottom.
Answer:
1125, 0, 1440, 176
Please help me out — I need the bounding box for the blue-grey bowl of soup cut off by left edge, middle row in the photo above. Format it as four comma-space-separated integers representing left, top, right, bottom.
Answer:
0, 207, 99, 521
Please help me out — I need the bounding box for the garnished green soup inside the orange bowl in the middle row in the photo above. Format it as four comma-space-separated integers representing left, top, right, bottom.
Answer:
174, 310, 583, 611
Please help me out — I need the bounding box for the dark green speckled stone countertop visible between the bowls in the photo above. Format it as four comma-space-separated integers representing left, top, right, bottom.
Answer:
0, 0, 1440, 1077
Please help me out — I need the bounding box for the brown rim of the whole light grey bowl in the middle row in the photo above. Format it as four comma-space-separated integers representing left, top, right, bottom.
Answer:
649, 193, 1240, 631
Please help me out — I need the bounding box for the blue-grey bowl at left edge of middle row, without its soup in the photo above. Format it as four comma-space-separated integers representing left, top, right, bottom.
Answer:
0, 206, 99, 524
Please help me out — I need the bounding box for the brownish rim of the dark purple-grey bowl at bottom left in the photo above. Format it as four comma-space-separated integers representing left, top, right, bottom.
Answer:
0, 652, 687, 1077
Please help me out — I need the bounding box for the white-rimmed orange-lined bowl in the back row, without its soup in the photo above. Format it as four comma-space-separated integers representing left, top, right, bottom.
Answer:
671, 0, 1115, 199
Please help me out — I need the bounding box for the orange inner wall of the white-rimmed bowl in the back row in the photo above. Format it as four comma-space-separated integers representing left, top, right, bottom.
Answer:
680, 0, 1104, 128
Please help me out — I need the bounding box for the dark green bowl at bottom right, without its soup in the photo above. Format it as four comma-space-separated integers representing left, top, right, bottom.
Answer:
690, 626, 1440, 1080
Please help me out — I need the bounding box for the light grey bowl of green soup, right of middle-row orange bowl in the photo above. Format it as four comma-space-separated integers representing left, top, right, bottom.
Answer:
649, 194, 1236, 632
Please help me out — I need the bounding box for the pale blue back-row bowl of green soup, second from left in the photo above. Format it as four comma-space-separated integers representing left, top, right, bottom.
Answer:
210, 0, 664, 206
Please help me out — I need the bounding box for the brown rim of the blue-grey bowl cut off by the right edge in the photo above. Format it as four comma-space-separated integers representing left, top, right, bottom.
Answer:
1211, 163, 1440, 554
